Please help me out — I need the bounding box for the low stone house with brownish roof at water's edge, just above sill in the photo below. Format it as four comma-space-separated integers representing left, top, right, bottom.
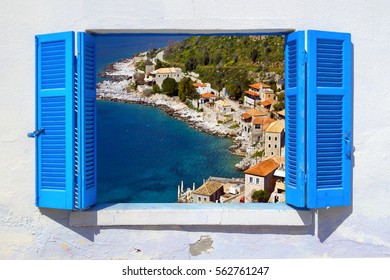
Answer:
192, 181, 225, 203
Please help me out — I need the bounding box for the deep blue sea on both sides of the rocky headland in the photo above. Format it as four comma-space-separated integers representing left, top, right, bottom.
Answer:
97, 35, 243, 203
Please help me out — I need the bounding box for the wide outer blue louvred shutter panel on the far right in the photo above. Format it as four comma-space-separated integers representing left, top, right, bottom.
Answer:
307, 31, 352, 208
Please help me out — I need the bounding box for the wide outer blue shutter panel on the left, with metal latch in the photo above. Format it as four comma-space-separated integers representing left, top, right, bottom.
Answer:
36, 32, 75, 209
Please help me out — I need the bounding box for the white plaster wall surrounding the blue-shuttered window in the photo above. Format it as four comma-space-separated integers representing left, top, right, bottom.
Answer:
0, 0, 390, 259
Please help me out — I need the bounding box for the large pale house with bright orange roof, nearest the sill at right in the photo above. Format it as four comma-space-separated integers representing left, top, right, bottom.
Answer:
244, 158, 279, 202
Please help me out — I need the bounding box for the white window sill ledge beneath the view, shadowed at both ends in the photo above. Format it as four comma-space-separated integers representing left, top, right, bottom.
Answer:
70, 203, 312, 227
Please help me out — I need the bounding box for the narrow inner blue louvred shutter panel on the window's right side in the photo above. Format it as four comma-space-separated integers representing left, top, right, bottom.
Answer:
284, 31, 306, 207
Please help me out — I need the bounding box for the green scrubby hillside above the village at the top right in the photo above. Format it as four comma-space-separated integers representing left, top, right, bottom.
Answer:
164, 36, 284, 90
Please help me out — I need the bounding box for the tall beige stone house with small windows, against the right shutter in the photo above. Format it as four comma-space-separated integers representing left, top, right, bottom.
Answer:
264, 120, 285, 157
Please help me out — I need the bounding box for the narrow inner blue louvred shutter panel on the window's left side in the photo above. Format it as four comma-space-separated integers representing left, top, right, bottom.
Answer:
75, 33, 97, 209
